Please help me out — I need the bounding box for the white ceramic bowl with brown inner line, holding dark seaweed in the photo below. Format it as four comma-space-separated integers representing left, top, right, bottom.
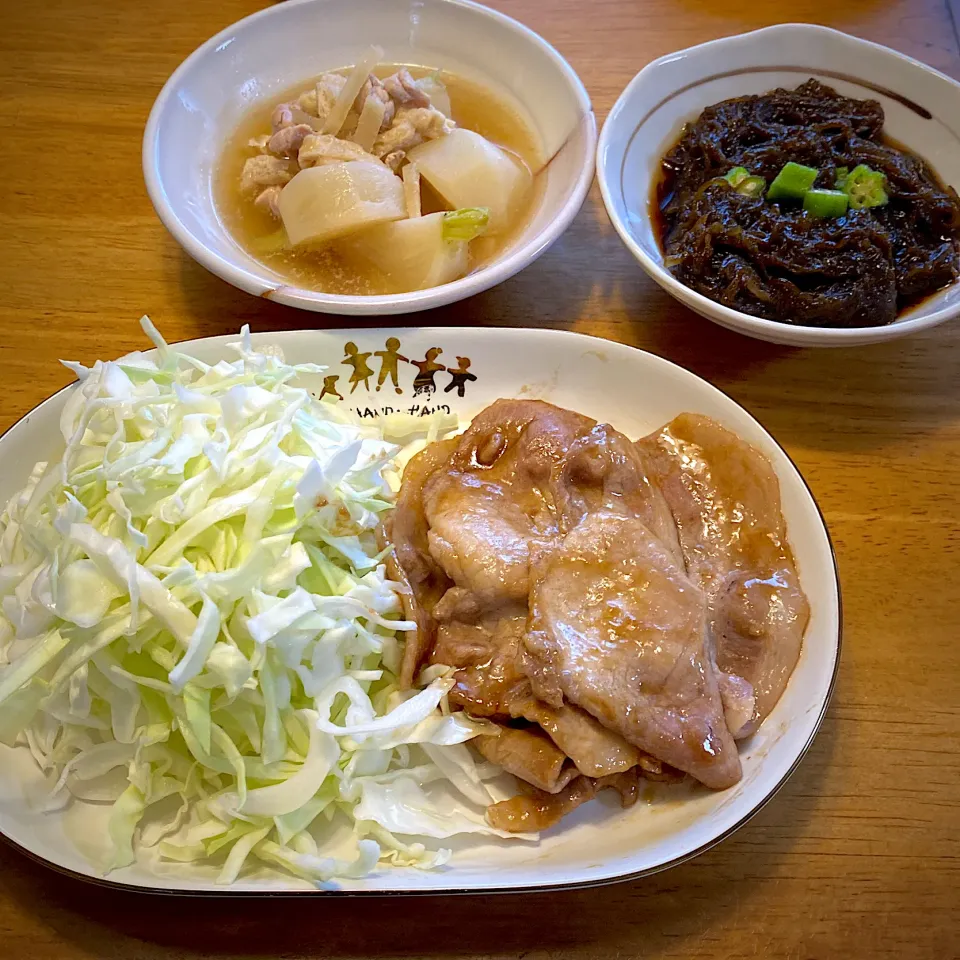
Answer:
597, 23, 960, 347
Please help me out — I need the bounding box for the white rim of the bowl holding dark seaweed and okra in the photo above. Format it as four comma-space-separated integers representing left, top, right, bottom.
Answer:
597, 23, 960, 347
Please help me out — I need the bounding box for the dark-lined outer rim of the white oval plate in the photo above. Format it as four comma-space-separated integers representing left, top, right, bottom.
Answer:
0, 326, 844, 898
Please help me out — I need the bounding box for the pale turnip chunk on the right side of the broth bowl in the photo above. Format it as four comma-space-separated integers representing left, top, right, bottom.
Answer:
407, 127, 533, 233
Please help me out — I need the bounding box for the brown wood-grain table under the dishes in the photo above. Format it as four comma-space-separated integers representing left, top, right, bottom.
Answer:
0, 0, 960, 960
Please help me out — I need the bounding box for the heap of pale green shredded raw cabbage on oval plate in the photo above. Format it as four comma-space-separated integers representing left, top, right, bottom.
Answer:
0, 318, 532, 883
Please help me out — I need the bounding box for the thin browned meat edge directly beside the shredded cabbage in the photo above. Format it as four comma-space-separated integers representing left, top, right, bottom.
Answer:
383, 438, 458, 690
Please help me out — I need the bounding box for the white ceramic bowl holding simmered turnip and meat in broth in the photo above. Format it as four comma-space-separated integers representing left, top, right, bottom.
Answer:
143, 0, 597, 315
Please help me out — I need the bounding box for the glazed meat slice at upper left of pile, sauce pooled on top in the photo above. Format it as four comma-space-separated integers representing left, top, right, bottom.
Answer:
423, 400, 593, 606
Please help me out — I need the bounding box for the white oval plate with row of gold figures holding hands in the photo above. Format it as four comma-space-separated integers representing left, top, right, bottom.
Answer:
0, 327, 840, 895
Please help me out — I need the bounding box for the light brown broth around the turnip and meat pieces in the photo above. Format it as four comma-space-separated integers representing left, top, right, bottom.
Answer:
214, 64, 542, 296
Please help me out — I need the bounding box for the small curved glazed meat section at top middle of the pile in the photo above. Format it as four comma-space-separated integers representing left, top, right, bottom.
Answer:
556, 424, 682, 562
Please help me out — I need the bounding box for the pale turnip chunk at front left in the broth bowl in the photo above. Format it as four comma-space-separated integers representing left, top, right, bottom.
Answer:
278, 160, 406, 246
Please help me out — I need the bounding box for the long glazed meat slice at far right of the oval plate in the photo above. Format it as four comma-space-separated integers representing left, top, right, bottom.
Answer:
640, 414, 810, 737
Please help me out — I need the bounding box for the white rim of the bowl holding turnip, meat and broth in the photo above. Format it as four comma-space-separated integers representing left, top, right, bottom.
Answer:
141, 0, 597, 315
